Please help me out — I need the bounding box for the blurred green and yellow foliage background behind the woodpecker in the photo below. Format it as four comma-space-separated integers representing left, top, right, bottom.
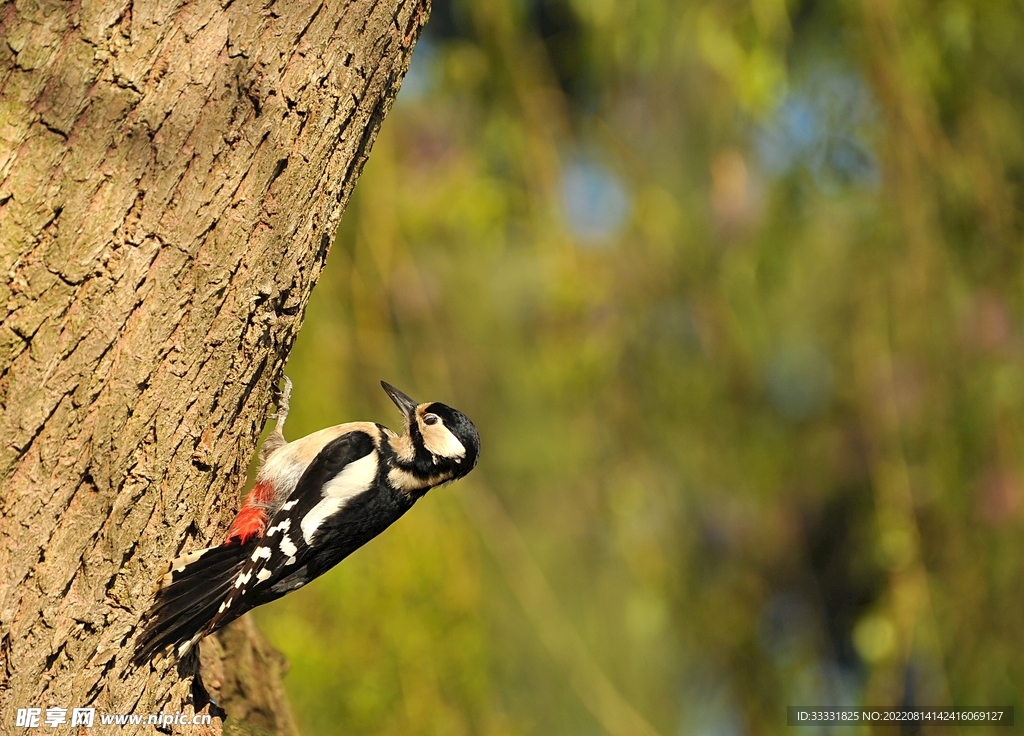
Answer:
249, 0, 1024, 736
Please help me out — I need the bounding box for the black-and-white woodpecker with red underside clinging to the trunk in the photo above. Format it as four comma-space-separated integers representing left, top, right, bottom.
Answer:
132, 377, 480, 665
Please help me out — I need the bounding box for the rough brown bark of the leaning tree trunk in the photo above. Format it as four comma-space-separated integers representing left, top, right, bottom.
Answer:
0, 0, 429, 734
